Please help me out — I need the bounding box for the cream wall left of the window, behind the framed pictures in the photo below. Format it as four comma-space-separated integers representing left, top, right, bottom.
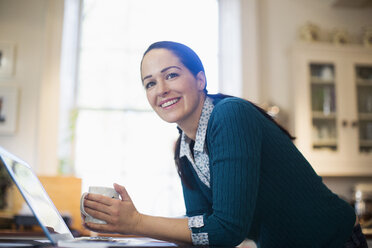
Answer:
0, 0, 63, 174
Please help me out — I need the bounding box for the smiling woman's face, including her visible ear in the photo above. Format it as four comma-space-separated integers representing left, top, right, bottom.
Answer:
141, 49, 205, 128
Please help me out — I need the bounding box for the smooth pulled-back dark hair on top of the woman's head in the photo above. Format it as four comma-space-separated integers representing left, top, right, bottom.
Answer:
141, 41, 208, 94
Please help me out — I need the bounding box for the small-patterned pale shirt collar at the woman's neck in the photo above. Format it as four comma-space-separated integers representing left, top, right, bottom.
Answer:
180, 97, 214, 157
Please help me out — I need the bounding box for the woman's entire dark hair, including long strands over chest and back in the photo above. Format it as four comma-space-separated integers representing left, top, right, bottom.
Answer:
141, 41, 295, 189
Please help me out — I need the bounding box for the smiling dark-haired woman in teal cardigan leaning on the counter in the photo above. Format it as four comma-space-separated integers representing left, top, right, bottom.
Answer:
78, 41, 367, 248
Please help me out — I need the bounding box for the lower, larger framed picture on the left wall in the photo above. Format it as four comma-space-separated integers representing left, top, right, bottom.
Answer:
0, 85, 18, 135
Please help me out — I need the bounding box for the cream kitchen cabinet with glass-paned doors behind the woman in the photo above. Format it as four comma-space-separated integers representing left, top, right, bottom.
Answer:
291, 43, 372, 176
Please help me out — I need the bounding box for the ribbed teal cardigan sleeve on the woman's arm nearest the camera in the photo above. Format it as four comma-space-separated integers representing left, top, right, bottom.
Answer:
191, 99, 262, 245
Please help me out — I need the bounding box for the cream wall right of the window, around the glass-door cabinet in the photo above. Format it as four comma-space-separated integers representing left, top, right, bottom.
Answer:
248, 0, 372, 200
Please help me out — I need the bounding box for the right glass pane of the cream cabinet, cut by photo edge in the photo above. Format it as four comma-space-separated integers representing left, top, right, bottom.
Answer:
355, 65, 372, 152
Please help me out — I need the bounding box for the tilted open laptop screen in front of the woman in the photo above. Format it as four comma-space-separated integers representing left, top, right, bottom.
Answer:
0, 147, 73, 243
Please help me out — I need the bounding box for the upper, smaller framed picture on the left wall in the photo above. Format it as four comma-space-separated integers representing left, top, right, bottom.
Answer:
0, 41, 14, 77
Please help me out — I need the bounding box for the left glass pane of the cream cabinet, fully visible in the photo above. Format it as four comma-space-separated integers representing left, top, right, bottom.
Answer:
309, 63, 338, 150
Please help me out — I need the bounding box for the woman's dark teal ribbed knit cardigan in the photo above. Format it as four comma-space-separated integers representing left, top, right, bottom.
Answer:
182, 98, 355, 248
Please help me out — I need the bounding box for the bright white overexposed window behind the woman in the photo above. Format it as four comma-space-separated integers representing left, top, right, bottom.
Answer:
73, 0, 218, 216
